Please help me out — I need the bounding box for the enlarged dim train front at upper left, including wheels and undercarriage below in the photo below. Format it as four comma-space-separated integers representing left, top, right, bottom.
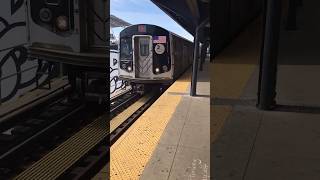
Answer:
27, 0, 109, 103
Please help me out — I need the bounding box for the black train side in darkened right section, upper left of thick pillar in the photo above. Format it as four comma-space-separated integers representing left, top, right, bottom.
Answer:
211, 0, 263, 54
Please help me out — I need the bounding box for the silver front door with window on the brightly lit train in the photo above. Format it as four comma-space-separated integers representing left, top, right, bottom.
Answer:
133, 35, 153, 78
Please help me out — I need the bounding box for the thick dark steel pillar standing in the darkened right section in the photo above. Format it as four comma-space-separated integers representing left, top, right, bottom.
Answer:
257, 0, 281, 110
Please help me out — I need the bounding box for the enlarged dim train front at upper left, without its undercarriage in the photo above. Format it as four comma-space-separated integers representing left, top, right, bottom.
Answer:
27, 0, 109, 68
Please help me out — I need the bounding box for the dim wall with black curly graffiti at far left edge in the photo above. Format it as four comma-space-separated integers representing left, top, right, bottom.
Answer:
0, 0, 49, 102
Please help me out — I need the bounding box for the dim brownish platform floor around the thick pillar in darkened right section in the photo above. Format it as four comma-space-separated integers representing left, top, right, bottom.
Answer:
211, 2, 320, 180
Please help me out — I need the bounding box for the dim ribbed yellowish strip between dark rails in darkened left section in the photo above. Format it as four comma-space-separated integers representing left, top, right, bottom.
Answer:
15, 113, 107, 180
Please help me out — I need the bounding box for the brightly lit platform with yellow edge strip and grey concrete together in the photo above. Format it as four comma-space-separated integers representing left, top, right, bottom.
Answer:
110, 62, 210, 180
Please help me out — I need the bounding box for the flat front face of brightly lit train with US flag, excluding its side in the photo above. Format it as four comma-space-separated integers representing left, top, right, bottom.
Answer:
119, 24, 173, 84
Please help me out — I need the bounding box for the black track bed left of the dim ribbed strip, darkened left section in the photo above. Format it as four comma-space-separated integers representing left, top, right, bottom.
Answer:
0, 97, 102, 179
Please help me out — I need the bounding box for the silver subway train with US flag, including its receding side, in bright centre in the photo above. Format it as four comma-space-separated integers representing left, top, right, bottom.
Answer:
119, 24, 193, 84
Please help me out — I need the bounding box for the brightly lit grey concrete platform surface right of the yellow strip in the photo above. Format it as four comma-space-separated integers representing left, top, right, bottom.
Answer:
141, 62, 210, 180
